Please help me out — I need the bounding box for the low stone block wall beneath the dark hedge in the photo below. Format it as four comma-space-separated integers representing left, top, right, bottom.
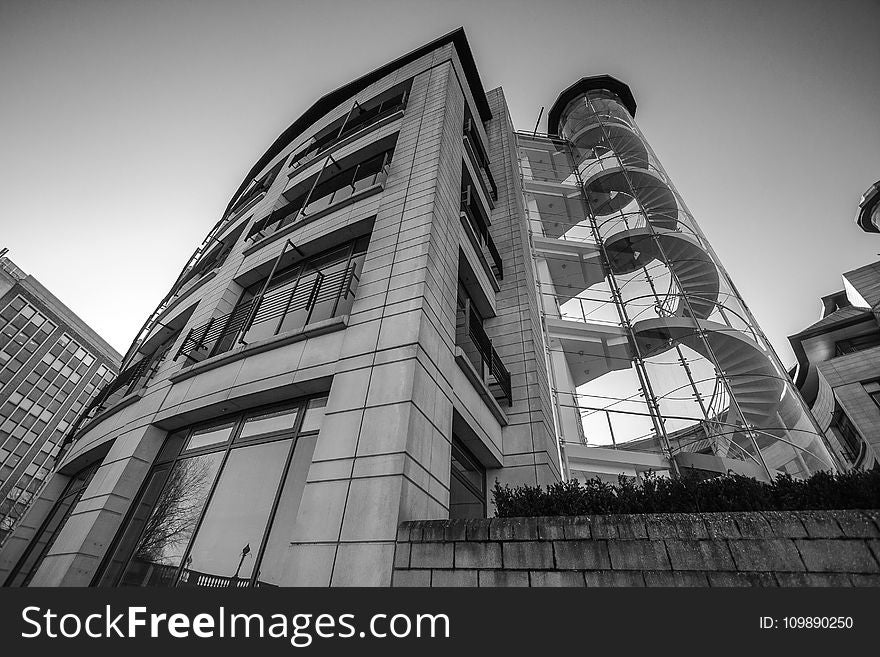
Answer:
392, 511, 880, 587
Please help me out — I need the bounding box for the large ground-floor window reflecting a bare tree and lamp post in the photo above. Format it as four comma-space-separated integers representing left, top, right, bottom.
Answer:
98, 398, 326, 587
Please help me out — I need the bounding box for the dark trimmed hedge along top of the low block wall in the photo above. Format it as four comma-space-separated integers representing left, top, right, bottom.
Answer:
492, 469, 880, 518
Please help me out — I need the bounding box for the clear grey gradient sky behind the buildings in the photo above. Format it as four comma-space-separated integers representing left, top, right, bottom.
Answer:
0, 0, 880, 364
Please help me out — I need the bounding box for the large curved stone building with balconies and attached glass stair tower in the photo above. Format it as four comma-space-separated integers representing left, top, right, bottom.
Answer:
0, 30, 835, 586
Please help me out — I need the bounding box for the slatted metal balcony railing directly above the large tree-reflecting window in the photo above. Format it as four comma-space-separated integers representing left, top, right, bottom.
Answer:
174, 263, 358, 362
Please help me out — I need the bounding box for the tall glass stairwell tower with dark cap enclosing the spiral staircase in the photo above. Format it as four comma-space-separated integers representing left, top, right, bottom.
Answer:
518, 76, 837, 480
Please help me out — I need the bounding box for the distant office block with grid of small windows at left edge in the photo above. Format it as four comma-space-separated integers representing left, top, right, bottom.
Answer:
0, 254, 122, 545
